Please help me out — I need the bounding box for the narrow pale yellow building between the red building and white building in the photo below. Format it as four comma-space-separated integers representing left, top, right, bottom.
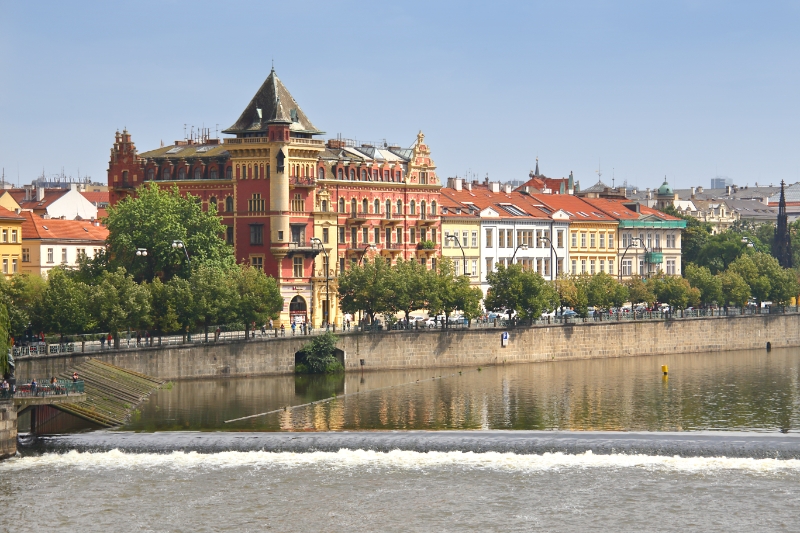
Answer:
440, 188, 481, 287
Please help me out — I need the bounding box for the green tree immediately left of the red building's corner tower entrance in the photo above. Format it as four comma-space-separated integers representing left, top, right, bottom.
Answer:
230, 265, 283, 334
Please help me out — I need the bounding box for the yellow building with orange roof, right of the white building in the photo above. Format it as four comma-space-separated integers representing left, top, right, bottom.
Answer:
533, 194, 619, 276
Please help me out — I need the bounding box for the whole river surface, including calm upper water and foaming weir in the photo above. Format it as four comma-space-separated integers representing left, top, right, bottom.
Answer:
0, 349, 800, 532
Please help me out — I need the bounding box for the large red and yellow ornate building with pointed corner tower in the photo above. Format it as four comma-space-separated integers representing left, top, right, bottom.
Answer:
108, 70, 441, 327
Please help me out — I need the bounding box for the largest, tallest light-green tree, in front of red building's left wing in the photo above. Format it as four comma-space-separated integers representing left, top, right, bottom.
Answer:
106, 183, 234, 281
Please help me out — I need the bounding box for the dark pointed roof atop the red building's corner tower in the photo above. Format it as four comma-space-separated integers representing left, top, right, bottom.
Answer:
222, 69, 324, 135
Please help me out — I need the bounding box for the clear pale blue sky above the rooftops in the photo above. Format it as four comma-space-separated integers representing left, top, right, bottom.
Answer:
0, 0, 800, 188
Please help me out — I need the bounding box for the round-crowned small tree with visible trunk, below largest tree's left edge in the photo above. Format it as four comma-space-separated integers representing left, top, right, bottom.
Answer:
89, 267, 150, 348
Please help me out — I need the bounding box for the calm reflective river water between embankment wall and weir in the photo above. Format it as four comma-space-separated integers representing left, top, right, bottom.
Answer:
125, 349, 800, 431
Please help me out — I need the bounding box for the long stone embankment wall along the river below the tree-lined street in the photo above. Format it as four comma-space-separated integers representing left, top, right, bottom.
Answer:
17, 314, 800, 380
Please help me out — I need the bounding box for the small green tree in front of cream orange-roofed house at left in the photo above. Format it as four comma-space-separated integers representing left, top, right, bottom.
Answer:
40, 267, 93, 334
